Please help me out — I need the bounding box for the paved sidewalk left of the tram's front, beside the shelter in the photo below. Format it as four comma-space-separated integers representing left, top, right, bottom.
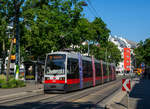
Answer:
0, 83, 43, 98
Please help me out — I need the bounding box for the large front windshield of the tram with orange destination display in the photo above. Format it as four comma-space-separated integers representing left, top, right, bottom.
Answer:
45, 54, 66, 75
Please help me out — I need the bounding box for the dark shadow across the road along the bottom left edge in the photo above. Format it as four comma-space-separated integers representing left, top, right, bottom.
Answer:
0, 102, 104, 109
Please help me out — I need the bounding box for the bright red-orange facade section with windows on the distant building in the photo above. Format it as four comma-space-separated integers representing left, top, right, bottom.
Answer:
124, 48, 131, 72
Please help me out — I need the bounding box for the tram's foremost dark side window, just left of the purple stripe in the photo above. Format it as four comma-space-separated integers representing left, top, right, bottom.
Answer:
67, 58, 79, 79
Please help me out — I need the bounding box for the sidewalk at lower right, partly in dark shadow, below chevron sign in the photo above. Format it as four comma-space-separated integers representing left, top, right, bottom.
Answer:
109, 79, 150, 109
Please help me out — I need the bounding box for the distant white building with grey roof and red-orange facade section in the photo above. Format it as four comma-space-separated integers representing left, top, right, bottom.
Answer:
109, 35, 137, 73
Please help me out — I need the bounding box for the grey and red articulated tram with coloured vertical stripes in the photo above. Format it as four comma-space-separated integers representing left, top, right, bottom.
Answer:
44, 52, 116, 93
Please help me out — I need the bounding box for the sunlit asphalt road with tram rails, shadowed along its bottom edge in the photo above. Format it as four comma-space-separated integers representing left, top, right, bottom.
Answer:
0, 79, 124, 109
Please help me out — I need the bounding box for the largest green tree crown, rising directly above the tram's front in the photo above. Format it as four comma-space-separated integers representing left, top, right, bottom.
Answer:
21, 0, 86, 58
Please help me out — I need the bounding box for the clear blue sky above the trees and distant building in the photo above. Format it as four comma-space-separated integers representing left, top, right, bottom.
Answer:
83, 0, 150, 42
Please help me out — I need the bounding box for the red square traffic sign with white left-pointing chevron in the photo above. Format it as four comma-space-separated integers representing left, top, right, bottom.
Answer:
122, 79, 131, 92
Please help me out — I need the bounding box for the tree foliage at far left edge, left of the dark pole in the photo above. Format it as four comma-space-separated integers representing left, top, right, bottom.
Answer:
0, 0, 13, 73
